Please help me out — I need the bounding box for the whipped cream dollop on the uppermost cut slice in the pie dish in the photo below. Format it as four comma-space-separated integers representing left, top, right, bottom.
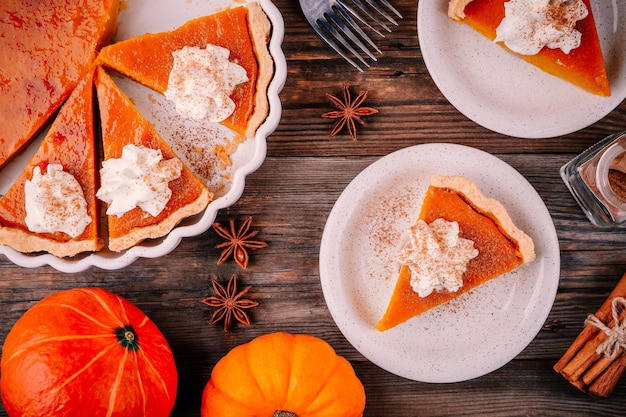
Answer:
165, 44, 248, 122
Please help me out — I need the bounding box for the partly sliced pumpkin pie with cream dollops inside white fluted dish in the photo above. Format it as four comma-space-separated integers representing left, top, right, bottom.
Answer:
0, 0, 274, 257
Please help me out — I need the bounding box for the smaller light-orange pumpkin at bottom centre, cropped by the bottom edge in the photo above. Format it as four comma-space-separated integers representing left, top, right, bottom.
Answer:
201, 333, 365, 417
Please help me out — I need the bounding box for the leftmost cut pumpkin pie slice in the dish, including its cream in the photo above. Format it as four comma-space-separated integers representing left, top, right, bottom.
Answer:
0, 68, 103, 257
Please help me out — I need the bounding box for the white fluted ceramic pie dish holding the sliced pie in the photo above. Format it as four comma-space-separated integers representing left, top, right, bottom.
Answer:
0, 0, 287, 272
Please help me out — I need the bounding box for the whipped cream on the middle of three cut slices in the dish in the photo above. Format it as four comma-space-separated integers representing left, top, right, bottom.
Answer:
96, 144, 183, 217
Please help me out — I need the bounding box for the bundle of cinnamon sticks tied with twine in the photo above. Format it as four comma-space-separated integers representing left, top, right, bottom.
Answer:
554, 274, 626, 398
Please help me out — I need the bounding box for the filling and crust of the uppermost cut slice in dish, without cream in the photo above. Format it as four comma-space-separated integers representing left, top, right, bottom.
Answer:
98, 3, 274, 136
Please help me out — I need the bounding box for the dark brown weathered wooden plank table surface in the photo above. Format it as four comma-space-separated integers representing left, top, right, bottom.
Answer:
0, 0, 626, 417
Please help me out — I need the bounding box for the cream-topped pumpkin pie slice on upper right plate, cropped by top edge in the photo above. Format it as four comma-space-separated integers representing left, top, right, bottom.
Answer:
448, 0, 611, 96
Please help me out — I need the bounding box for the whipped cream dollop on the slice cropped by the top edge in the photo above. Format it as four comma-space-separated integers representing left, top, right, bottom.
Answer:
495, 0, 589, 55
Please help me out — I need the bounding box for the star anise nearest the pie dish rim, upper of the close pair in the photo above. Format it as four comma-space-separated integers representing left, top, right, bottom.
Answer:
213, 216, 267, 269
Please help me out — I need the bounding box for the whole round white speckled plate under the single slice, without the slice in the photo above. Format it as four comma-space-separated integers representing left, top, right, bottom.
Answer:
320, 144, 560, 383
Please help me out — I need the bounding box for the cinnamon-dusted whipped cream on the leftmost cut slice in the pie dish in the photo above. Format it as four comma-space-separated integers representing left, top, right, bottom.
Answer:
24, 164, 91, 238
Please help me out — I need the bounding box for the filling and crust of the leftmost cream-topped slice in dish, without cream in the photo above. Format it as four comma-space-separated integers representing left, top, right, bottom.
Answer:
0, 68, 102, 257
